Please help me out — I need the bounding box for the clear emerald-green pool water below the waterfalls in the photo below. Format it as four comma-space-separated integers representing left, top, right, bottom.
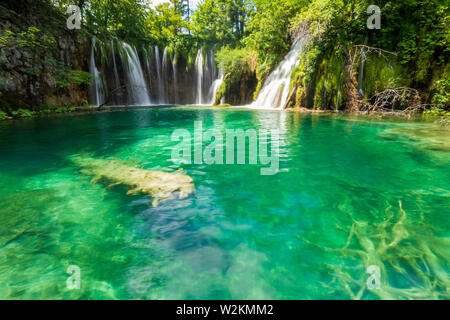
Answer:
0, 108, 450, 299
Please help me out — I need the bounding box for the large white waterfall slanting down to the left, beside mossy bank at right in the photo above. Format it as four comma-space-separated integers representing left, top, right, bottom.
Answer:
251, 37, 306, 109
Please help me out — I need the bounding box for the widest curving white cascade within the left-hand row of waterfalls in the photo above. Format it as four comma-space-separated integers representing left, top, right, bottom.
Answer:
122, 42, 150, 105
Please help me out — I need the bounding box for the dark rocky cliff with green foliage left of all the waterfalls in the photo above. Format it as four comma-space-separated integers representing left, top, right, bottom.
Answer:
0, 1, 90, 112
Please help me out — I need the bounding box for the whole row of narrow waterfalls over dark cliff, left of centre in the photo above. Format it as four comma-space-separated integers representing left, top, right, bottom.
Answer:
89, 38, 223, 105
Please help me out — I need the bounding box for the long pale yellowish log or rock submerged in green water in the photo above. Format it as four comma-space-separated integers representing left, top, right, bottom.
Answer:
71, 157, 195, 207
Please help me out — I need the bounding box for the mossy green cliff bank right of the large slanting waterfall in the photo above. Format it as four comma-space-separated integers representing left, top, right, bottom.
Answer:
290, 46, 450, 111
